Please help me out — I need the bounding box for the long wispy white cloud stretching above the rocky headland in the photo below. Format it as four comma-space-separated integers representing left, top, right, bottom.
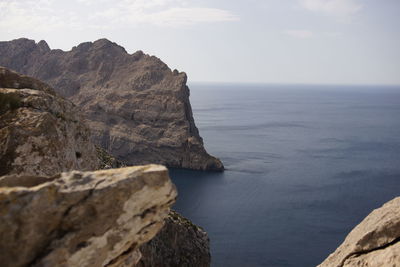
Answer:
0, 0, 239, 33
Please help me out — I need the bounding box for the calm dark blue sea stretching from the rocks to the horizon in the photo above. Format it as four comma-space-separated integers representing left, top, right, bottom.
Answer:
170, 84, 400, 267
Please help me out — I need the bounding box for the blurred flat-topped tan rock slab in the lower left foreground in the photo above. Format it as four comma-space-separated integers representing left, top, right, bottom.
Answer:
0, 165, 176, 267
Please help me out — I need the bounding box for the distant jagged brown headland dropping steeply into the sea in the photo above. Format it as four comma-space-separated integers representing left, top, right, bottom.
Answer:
0, 39, 223, 170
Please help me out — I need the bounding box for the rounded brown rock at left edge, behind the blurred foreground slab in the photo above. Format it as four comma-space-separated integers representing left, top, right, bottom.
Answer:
0, 67, 100, 176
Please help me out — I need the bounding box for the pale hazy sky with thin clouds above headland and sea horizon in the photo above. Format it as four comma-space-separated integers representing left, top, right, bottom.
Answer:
0, 0, 400, 85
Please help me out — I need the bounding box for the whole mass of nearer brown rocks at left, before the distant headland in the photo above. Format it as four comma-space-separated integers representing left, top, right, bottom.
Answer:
0, 67, 210, 267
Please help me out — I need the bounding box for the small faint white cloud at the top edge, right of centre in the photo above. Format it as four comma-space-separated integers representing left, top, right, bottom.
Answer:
299, 0, 362, 18
